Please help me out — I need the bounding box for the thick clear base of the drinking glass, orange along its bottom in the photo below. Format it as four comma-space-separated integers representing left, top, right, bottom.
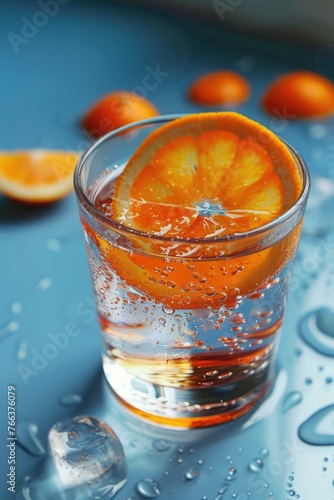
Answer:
103, 354, 272, 429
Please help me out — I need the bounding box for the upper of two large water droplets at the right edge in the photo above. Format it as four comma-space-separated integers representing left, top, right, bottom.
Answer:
298, 307, 334, 357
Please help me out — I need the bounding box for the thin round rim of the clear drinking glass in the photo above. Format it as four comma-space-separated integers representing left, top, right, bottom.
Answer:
73, 113, 311, 245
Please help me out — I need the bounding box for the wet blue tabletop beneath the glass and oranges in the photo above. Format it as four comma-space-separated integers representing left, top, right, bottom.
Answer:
0, 0, 334, 500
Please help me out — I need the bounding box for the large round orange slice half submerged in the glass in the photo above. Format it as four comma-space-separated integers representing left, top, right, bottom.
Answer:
90, 113, 301, 309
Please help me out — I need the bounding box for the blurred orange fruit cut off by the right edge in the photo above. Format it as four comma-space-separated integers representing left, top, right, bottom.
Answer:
263, 71, 334, 119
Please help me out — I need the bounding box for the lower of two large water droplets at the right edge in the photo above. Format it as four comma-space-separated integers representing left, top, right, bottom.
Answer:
298, 405, 334, 446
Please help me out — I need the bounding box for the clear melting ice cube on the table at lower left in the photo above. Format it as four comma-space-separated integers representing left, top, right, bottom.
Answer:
49, 416, 127, 500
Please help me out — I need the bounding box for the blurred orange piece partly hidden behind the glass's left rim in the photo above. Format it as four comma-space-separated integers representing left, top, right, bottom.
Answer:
82, 90, 159, 137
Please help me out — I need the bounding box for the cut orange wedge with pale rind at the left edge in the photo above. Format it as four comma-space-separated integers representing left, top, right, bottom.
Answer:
0, 149, 79, 203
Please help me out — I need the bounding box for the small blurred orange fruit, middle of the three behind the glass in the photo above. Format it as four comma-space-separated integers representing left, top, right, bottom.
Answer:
188, 71, 250, 106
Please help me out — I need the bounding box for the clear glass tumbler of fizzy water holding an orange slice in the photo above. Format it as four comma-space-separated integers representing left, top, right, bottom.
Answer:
74, 116, 310, 428
